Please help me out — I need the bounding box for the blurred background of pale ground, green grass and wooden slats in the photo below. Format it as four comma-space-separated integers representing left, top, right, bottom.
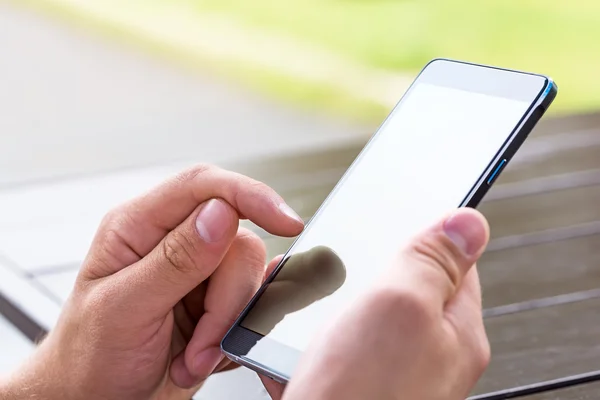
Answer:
0, 0, 600, 400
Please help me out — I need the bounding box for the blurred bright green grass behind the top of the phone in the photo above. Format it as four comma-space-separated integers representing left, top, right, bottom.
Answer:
188, 0, 600, 111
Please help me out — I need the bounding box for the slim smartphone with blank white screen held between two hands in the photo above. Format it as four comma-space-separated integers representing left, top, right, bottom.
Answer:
221, 59, 557, 383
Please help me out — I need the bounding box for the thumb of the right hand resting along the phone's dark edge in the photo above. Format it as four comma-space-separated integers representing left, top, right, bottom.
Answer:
389, 208, 489, 309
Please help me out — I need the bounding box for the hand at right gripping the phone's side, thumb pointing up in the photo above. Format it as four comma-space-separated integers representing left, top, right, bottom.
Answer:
263, 209, 490, 400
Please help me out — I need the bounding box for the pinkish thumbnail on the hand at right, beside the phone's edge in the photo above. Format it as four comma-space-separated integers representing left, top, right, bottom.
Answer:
444, 209, 488, 256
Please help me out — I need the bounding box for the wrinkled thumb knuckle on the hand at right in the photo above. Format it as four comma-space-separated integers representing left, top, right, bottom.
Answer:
408, 235, 460, 287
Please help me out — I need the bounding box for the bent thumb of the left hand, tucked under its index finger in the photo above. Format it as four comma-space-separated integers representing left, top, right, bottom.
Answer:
121, 199, 239, 312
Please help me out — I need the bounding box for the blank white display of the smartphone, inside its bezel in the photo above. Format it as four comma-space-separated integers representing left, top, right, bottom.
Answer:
241, 83, 530, 351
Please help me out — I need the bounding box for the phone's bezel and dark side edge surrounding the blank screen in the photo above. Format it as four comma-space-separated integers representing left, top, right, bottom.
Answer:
221, 58, 558, 390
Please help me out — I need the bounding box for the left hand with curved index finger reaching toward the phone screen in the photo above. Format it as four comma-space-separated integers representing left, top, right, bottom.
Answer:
6, 166, 303, 400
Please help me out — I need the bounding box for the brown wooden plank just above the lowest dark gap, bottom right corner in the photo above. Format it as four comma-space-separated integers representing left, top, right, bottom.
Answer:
474, 299, 600, 394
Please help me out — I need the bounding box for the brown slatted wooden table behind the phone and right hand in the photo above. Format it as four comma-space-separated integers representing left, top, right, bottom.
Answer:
231, 114, 600, 400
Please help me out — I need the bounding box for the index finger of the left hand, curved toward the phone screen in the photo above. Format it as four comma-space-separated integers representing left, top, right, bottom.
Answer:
93, 165, 304, 268
